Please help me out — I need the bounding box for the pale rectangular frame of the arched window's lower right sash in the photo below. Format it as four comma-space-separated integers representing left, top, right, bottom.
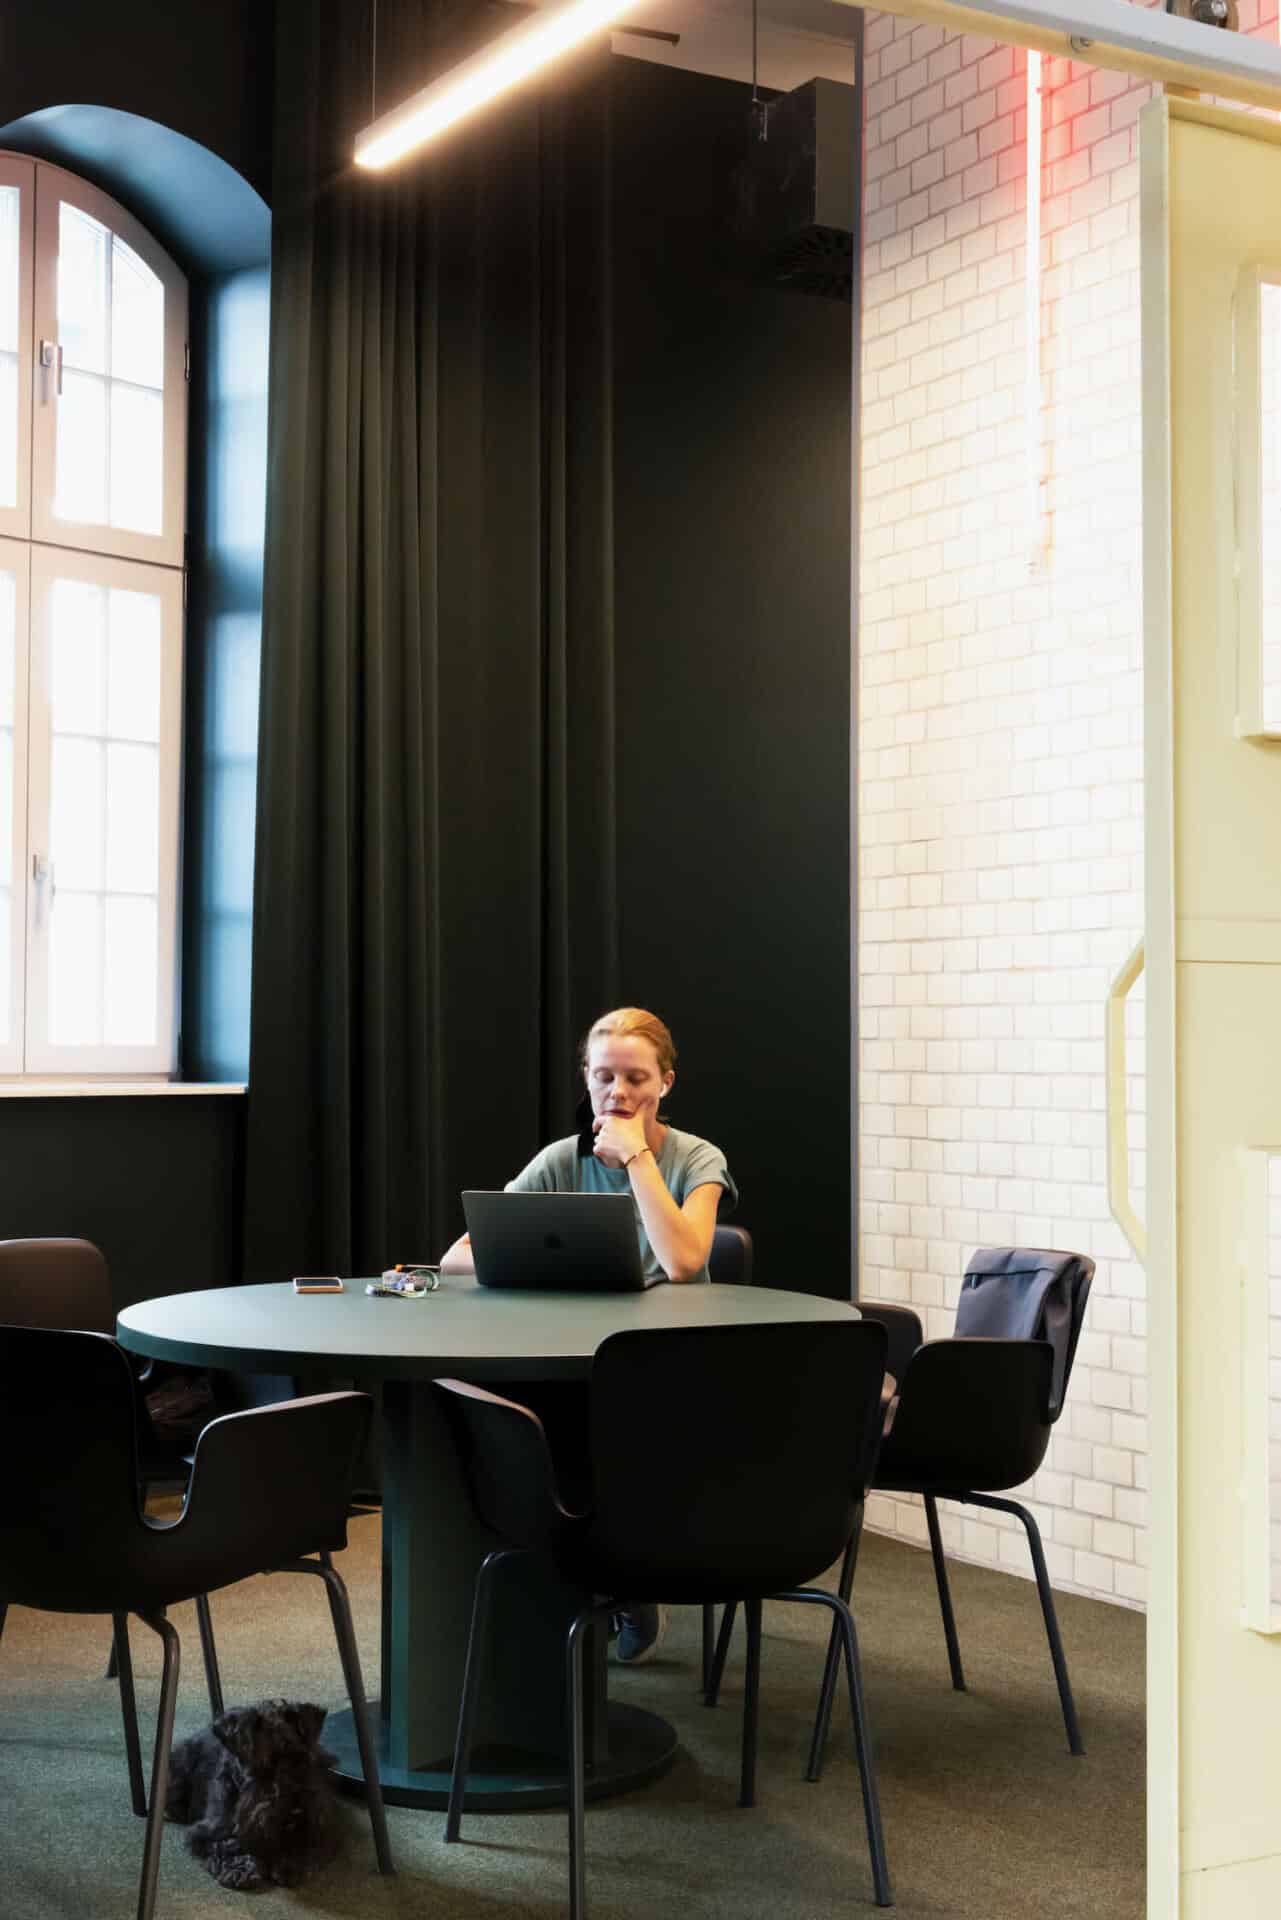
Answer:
25, 543, 182, 1075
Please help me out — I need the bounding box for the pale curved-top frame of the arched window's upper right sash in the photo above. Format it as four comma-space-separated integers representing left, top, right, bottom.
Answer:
31, 161, 186, 566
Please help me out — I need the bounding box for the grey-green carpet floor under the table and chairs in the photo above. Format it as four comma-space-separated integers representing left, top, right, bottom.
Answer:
0, 1515, 1143, 1920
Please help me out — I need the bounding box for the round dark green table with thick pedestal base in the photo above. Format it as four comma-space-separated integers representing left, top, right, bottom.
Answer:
117, 1279, 857, 1811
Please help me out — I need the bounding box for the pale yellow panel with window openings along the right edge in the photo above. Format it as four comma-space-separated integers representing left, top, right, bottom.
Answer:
1143, 102, 1281, 1920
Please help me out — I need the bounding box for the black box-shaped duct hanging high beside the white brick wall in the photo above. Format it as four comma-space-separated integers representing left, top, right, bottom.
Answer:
737, 81, 858, 300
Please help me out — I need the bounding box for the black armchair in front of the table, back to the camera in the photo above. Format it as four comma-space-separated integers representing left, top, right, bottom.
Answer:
438, 1323, 893, 1920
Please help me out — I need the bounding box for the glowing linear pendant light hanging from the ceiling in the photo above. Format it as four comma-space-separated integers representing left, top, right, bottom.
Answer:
355, 0, 636, 169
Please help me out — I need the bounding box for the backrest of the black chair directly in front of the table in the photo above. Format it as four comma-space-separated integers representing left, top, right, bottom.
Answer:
592, 1319, 885, 1599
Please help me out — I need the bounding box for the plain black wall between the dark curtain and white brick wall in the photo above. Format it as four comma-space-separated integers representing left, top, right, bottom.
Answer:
615, 60, 853, 1298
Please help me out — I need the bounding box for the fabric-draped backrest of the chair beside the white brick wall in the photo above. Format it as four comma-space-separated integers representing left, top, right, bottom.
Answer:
956, 1246, 1095, 1421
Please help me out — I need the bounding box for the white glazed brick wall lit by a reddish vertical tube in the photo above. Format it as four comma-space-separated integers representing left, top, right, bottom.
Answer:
858, 0, 1281, 1605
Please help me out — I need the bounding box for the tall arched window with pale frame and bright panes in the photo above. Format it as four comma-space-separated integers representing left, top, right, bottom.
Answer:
0, 154, 186, 1075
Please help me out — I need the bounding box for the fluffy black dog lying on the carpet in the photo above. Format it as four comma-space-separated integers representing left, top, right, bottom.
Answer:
165, 1699, 340, 1893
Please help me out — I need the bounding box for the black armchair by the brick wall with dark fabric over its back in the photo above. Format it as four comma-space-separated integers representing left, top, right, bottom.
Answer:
810, 1246, 1095, 1780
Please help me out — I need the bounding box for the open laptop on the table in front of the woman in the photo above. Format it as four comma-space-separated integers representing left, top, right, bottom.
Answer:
463, 1192, 661, 1294
